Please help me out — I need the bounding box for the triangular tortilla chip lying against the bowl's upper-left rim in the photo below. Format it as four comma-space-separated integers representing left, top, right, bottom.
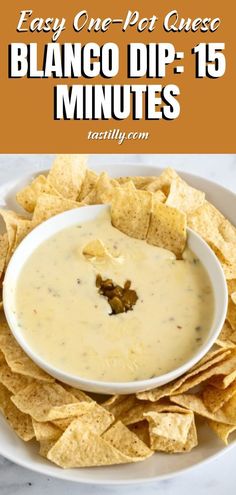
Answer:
32, 194, 82, 225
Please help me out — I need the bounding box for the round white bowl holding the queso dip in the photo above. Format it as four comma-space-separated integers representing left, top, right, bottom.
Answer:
3, 205, 228, 394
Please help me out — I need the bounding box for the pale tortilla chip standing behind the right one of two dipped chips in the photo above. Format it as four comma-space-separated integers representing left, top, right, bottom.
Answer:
166, 177, 205, 213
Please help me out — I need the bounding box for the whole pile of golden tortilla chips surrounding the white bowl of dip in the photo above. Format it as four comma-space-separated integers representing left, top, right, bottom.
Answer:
0, 155, 236, 468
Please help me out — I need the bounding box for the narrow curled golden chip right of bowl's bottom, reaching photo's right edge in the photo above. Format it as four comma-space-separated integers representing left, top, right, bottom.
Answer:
170, 394, 235, 425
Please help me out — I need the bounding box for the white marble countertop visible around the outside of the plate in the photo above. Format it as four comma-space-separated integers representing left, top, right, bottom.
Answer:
0, 154, 236, 495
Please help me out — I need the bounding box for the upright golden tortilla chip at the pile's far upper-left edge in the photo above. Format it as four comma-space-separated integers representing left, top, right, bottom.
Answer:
16, 175, 47, 213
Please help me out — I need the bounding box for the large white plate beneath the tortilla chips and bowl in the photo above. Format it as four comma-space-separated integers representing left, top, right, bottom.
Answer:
0, 165, 236, 485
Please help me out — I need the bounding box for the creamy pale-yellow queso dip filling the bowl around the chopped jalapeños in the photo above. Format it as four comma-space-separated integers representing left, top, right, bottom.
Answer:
16, 212, 214, 382
